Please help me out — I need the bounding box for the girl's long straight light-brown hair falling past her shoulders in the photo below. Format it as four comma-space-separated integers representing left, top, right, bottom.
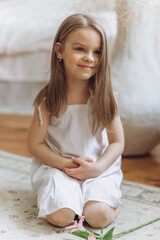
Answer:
34, 14, 117, 130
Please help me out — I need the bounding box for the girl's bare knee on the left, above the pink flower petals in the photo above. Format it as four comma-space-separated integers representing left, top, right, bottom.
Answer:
46, 208, 75, 227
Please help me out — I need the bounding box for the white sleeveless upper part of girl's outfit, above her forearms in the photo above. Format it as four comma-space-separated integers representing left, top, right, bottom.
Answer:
42, 101, 121, 176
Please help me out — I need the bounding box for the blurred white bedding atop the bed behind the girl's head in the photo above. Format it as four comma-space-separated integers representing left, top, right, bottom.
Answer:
0, 0, 117, 55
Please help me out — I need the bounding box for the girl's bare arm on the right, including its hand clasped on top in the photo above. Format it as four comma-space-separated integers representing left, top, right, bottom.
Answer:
64, 115, 124, 180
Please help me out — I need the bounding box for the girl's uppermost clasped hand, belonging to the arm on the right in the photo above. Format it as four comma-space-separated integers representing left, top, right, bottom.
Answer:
63, 157, 98, 181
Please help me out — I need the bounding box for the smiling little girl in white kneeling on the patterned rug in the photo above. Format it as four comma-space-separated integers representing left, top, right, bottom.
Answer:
28, 14, 124, 228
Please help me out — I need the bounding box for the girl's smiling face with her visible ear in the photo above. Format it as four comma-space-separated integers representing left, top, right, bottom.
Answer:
56, 28, 101, 81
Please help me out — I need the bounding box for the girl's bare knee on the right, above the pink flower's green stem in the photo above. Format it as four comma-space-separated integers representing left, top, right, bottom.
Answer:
83, 202, 118, 228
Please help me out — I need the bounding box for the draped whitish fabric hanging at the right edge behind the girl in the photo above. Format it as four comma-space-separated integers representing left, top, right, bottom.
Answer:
111, 0, 160, 155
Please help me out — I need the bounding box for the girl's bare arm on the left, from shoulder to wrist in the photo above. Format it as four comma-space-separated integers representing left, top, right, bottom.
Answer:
28, 102, 77, 170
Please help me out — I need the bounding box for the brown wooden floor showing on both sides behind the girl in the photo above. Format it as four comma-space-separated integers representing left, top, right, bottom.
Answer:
0, 115, 160, 187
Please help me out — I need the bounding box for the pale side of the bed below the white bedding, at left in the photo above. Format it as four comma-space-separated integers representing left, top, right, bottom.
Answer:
0, 51, 50, 82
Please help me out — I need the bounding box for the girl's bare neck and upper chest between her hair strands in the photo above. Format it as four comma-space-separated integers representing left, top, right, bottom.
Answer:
67, 81, 90, 105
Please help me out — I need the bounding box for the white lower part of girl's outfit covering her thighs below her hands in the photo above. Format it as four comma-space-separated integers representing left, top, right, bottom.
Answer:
32, 160, 122, 218
